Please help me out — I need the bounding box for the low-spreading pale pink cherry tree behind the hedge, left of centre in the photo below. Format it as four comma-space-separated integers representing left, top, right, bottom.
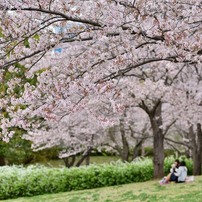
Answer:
23, 110, 104, 167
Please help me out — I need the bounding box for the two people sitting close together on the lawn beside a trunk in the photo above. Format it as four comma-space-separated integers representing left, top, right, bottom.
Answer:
160, 159, 187, 184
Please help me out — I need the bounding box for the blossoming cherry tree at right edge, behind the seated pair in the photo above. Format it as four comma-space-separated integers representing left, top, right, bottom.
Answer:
168, 65, 202, 175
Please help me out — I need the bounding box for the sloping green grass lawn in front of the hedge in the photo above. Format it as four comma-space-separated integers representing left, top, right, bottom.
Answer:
2, 176, 202, 202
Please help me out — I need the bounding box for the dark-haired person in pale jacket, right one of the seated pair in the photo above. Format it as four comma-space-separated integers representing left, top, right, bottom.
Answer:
160, 161, 187, 184
